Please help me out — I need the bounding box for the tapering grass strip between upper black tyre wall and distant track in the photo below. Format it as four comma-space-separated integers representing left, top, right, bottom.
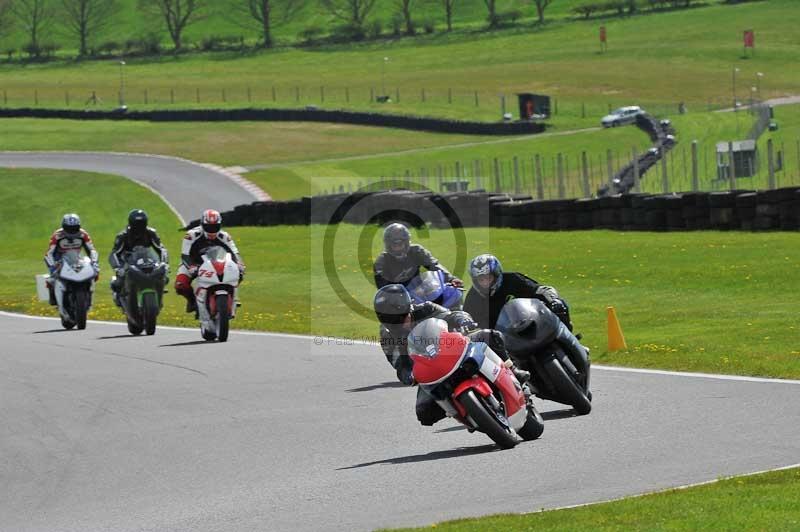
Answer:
0, 118, 500, 166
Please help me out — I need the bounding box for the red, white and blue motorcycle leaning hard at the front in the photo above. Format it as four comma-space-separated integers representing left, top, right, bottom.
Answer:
408, 318, 544, 449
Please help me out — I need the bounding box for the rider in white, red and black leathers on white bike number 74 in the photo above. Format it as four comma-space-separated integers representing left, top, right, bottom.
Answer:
175, 209, 245, 312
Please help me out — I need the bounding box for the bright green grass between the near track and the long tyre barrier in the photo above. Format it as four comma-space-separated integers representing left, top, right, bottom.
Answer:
0, 170, 800, 378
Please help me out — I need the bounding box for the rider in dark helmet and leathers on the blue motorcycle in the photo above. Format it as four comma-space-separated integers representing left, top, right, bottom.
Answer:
373, 223, 464, 288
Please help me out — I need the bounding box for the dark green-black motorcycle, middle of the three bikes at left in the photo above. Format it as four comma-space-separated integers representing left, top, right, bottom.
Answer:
119, 246, 167, 335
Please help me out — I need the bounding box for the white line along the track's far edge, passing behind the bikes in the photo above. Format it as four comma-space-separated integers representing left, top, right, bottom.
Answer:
0, 310, 800, 384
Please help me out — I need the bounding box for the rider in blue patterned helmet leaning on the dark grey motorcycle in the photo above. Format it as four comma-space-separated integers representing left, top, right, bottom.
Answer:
464, 253, 572, 331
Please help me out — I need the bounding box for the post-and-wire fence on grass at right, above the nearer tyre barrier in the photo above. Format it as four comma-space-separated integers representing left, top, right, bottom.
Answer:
320, 138, 800, 200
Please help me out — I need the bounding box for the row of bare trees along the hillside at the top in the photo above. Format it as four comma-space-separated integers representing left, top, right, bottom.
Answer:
0, 0, 554, 58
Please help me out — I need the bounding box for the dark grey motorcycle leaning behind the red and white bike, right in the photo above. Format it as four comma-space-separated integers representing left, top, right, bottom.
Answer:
495, 298, 592, 415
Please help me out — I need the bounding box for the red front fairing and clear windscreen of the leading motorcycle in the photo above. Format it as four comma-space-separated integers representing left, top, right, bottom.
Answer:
408, 318, 469, 384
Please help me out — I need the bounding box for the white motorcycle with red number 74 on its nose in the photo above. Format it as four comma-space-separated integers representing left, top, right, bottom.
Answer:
195, 246, 240, 342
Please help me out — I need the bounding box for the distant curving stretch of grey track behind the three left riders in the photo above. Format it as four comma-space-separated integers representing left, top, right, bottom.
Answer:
0, 152, 259, 222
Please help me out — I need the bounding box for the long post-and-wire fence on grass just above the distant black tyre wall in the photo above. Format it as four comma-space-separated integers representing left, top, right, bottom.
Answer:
0, 84, 730, 121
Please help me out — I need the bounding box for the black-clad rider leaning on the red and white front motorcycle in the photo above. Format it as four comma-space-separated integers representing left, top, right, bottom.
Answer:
373, 283, 530, 426
